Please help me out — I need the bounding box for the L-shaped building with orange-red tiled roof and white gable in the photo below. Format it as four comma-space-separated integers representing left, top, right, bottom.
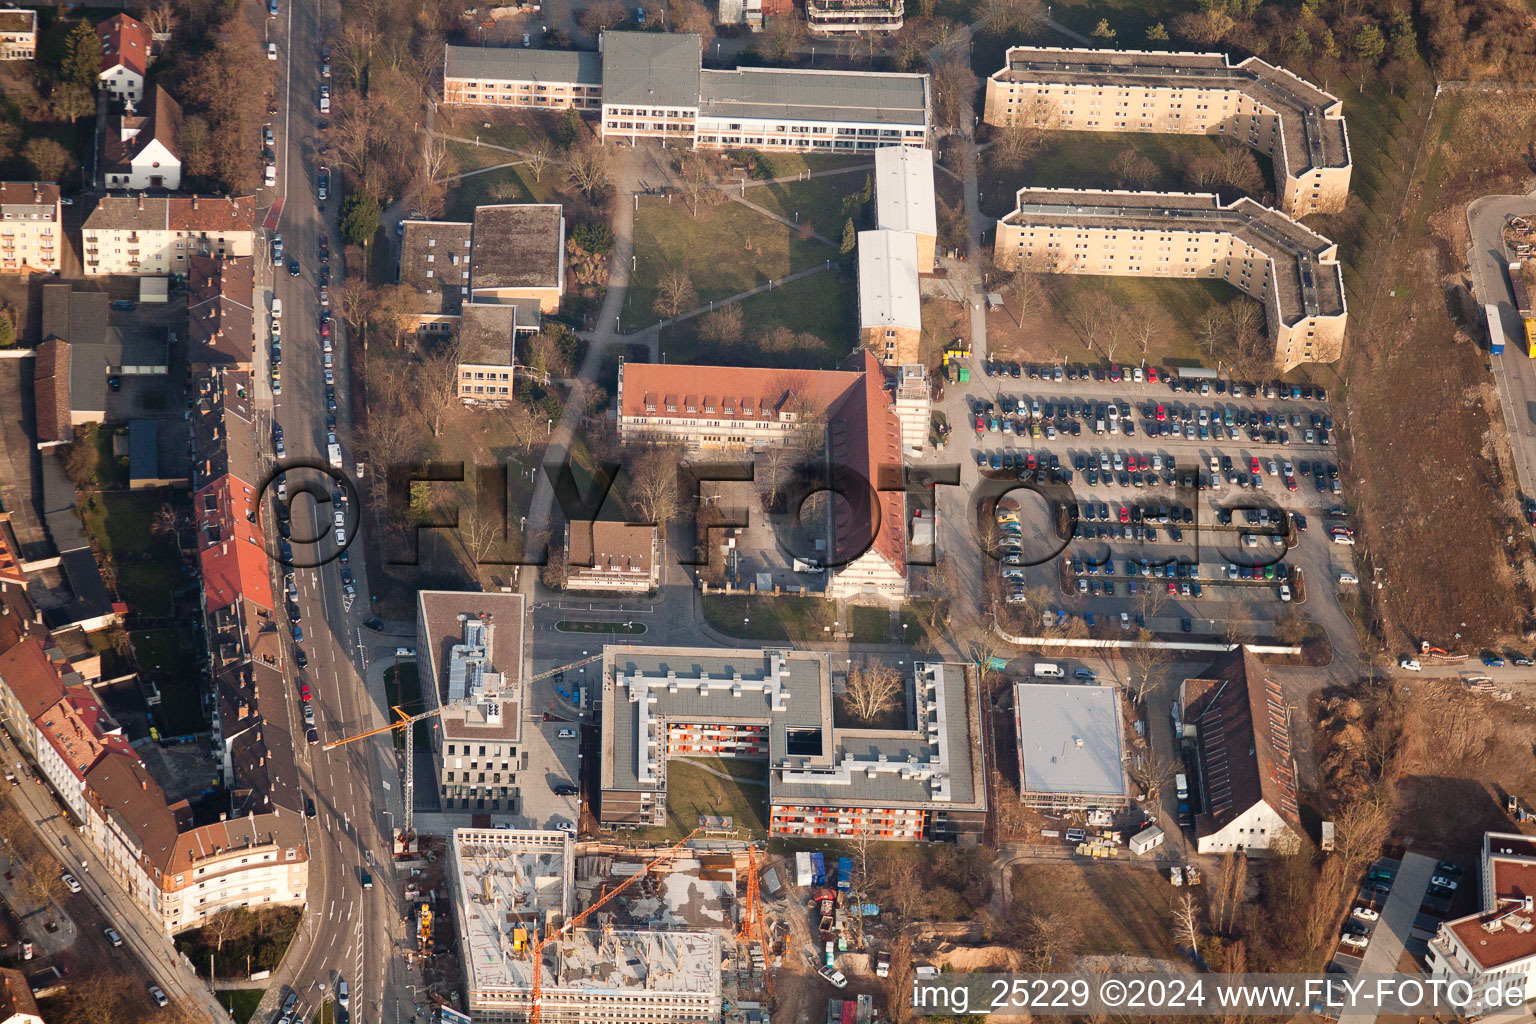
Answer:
617, 350, 906, 602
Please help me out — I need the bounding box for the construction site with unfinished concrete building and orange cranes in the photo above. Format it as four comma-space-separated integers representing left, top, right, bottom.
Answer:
445, 829, 780, 1024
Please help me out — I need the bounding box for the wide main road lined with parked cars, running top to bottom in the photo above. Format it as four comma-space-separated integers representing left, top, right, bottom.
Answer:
255, 0, 412, 1024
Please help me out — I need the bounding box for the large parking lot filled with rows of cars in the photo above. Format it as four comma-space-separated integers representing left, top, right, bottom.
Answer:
949, 356, 1355, 634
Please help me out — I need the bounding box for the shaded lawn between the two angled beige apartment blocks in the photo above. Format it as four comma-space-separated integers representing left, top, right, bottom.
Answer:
977, 132, 1275, 216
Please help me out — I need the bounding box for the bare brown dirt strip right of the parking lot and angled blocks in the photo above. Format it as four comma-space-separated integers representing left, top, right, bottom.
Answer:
1324, 88, 1531, 651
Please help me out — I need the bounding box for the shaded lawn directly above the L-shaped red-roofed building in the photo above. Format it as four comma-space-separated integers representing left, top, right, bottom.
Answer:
662, 264, 859, 370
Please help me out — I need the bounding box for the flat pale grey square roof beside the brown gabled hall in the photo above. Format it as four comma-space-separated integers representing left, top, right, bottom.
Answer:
1014, 683, 1126, 798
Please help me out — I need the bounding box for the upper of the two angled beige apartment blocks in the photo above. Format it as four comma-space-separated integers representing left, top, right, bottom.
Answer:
985, 46, 1352, 216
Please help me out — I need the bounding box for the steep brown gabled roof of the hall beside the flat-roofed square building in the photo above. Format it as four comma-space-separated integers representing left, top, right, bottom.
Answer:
1184, 646, 1301, 835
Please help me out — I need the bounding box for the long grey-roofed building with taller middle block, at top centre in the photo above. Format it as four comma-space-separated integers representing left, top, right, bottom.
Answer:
444, 32, 929, 152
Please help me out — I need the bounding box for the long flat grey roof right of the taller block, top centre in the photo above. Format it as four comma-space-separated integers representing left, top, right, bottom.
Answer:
697, 68, 928, 127
